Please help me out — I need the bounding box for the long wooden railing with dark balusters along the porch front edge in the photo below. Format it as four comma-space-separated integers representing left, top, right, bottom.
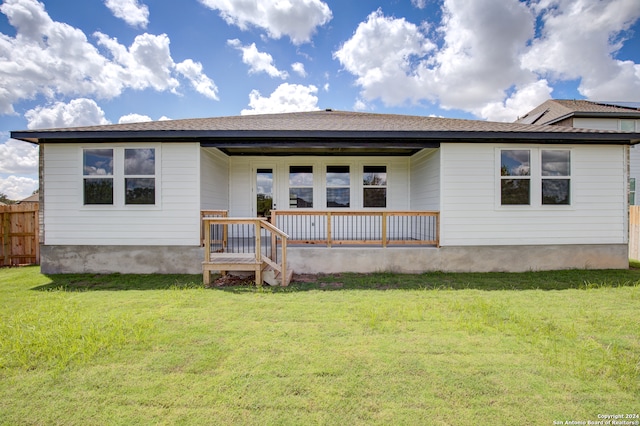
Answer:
271, 210, 440, 247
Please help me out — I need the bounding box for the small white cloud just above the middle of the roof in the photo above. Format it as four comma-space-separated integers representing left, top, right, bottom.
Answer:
240, 83, 320, 115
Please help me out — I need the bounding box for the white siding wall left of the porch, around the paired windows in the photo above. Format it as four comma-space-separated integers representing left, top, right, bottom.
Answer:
44, 143, 200, 245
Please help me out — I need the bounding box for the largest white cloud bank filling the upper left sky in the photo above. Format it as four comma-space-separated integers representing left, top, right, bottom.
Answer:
0, 0, 215, 114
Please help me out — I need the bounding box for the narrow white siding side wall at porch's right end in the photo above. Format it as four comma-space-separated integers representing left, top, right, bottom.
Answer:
410, 149, 440, 211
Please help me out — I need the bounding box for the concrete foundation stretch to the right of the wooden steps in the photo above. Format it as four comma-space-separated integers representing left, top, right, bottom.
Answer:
287, 244, 629, 274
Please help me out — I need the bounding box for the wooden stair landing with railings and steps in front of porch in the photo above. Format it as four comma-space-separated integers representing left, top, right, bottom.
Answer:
202, 216, 291, 286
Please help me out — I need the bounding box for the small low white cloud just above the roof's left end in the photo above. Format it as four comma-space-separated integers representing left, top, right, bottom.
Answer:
24, 98, 110, 129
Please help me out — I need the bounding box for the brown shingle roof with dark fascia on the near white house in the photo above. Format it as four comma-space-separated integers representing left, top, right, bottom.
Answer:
11, 110, 640, 154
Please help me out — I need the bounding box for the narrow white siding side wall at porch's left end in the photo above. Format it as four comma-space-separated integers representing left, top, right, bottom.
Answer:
200, 148, 229, 210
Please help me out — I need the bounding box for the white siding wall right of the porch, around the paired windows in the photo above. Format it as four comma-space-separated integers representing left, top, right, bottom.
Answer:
440, 144, 626, 246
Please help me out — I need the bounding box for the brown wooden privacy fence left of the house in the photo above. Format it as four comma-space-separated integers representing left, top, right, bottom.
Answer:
0, 203, 40, 266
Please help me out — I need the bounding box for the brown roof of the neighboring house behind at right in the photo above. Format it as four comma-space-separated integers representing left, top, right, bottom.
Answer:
515, 99, 640, 125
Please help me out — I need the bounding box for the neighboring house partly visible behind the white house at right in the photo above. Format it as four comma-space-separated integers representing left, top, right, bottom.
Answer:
516, 99, 640, 205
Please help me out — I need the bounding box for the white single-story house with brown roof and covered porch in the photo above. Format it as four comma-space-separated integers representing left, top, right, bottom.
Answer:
11, 110, 640, 273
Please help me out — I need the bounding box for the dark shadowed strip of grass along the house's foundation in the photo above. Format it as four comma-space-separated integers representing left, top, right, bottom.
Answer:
33, 268, 640, 293
